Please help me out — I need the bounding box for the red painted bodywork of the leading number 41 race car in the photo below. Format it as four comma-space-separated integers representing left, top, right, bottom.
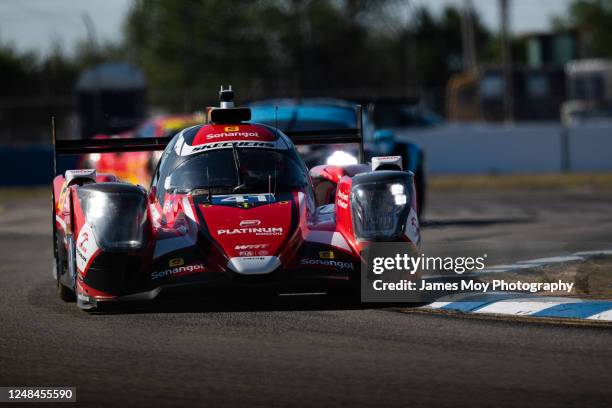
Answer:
53, 119, 417, 301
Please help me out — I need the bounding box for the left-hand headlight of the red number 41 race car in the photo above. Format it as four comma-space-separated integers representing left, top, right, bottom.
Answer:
78, 188, 146, 251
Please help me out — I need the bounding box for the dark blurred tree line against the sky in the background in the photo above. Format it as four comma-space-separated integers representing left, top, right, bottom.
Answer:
0, 0, 612, 140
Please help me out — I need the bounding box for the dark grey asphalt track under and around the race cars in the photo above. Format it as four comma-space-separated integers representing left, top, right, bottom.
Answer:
0, 192, 612, 407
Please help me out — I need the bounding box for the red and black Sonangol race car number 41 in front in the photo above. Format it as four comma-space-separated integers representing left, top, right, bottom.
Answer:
53, 86, 420, 310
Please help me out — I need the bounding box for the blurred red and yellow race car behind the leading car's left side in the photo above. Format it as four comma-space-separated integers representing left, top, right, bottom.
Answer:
79, 114, 205, 186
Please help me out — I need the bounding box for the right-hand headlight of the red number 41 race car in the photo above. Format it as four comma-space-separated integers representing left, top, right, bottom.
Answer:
351, 171, 412, 241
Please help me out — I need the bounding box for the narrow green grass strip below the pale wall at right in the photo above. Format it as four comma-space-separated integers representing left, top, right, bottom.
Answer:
429, 172, 612, 191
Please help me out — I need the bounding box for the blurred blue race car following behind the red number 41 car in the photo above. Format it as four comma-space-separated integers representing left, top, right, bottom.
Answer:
249, 98, 427, 216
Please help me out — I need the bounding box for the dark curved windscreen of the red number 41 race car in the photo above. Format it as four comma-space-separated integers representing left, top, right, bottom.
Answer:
164, 148, 308, 194
